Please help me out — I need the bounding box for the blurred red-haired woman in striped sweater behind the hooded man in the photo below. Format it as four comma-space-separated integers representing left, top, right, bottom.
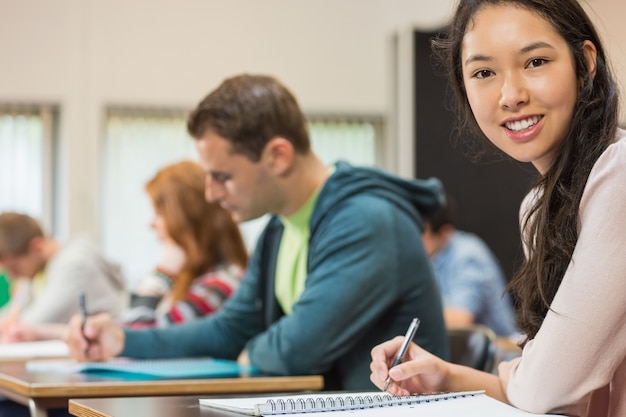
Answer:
123, 161, 248, 328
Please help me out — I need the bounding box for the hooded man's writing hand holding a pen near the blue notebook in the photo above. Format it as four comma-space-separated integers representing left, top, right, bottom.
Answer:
63, 313, 124, 361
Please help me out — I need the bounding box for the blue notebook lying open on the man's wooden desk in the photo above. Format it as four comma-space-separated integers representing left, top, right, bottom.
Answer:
26, 358, 258, 379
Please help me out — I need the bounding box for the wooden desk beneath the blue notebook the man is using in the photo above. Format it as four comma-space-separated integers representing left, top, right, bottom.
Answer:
0, 362, 324, 417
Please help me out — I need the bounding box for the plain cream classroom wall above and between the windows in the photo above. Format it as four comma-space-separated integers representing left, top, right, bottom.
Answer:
0, 0, 626, 237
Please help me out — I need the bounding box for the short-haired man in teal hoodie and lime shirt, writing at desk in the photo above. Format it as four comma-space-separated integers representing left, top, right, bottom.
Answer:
65, 75, 448, 390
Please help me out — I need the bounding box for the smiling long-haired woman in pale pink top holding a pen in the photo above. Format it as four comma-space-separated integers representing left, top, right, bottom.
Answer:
371, 0, 626, 417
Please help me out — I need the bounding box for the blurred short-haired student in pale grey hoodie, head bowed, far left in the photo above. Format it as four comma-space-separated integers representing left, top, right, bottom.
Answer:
0, 212, 125, 331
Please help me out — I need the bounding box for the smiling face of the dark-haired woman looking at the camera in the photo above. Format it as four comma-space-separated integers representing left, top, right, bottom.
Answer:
461, 4, 580, 174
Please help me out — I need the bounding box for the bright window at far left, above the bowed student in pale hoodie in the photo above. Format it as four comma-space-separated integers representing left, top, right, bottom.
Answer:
0, 104, 57, 231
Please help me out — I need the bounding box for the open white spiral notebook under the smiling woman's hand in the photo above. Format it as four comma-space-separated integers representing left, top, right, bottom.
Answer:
200, 391, 548, 417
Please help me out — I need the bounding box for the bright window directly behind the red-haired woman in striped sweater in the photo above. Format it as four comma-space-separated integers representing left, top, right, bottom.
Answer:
100, 109, 197, 284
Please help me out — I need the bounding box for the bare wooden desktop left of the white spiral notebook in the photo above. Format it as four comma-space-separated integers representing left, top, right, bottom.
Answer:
69, 395, 260, 417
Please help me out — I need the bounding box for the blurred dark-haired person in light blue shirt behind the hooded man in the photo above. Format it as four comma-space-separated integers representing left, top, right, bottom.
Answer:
422, 194, 515, 337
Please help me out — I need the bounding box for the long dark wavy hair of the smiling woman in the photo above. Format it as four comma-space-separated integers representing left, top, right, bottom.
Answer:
432, 0, 618, 341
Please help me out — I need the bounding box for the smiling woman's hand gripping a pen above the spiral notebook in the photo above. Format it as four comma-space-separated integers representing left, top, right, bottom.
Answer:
370, 336, 450, 395
